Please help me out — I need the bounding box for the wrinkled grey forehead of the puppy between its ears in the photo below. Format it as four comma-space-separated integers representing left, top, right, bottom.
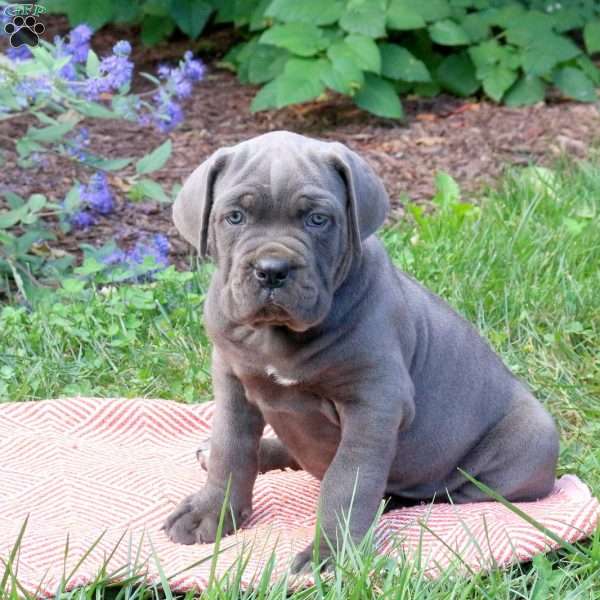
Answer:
215, 136, 346, 204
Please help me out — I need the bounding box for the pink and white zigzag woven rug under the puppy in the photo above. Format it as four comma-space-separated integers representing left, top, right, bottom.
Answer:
0, 398, 600, 597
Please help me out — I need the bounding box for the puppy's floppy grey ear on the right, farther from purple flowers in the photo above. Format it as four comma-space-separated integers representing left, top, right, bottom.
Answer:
330, 143, 390, 256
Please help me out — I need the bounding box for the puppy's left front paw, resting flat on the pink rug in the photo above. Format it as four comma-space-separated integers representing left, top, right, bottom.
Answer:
162, 488, 252, 545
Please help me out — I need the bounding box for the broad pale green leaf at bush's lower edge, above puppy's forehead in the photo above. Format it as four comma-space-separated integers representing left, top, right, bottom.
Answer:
273, 58, 327, 108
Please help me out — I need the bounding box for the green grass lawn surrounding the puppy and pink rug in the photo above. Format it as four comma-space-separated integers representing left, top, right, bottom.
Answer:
0, 157, 600, 600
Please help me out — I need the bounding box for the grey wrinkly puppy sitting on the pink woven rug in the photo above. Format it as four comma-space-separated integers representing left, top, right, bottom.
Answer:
164, 131, 558, 571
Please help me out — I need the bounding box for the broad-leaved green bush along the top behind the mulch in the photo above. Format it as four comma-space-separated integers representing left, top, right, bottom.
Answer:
44, 0, 600, 118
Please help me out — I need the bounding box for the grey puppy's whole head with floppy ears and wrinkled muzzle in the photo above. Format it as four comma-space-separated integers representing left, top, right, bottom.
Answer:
173, 131, 389, 331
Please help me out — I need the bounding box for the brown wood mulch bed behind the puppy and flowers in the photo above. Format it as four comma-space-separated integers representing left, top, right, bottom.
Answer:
0, 20, 600, 262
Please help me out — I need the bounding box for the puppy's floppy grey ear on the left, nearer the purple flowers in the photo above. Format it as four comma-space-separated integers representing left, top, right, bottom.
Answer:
173, 148, 229, 258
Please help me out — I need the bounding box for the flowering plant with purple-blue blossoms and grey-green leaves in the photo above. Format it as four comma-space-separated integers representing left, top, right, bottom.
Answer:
0, 25, 204, 297
